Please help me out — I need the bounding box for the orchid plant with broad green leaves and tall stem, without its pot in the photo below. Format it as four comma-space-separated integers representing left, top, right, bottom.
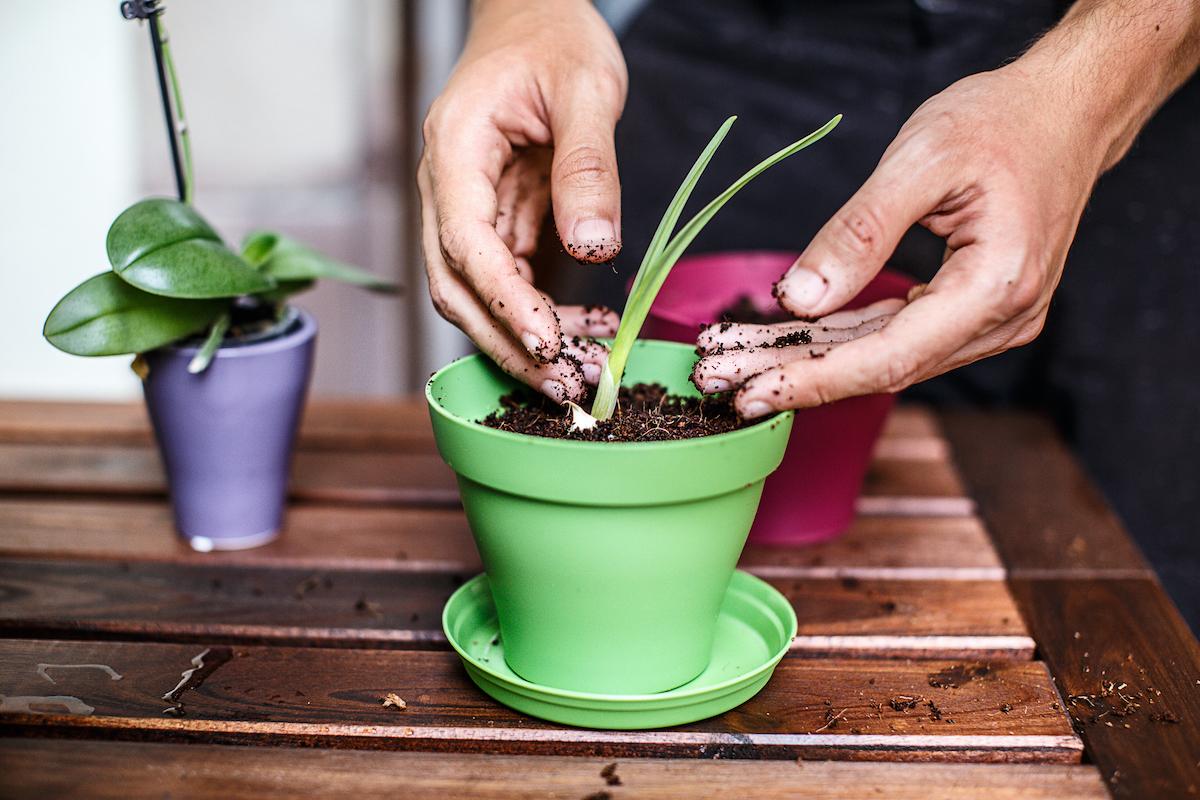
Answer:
42, 0, 397, 373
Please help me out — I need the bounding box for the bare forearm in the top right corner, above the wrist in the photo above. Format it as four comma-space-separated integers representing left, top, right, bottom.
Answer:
1012, 0, 1200, 172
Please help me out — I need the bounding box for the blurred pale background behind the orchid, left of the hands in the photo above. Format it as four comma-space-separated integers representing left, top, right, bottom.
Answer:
0, 0, 468, 398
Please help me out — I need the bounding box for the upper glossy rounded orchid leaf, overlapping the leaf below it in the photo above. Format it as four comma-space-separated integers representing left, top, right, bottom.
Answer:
108, 198, 275, 299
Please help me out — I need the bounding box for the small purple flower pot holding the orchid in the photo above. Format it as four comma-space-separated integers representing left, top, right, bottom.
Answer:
143, 304, 317, 552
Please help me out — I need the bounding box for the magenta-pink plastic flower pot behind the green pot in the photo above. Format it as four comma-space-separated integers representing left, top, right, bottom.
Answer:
643, 252, 913, 546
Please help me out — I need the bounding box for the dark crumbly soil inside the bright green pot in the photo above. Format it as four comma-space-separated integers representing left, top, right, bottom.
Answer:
481, 384, 757, 441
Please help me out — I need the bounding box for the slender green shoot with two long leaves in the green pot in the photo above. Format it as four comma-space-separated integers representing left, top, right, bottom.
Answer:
592, 114, 841, 420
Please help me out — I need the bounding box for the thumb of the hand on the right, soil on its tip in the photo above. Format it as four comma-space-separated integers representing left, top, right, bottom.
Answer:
775, 153, 942, 318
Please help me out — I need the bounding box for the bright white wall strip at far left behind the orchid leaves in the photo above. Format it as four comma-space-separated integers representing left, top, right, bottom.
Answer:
0, 0, 144, 397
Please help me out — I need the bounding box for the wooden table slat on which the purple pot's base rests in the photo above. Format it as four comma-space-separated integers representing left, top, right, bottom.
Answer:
0, 495, 1003, 581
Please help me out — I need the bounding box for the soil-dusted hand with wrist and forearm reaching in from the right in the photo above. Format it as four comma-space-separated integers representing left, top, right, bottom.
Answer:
694, 0, 1200, 417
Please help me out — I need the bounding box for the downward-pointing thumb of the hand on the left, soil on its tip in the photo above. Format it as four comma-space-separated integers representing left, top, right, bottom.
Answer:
550, 77, 620, 264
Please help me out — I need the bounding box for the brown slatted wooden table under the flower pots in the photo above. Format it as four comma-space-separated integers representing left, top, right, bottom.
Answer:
0, 402, 1200, 800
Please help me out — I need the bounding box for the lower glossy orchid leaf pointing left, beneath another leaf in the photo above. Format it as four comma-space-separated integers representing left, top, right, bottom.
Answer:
42, 272, 229, 355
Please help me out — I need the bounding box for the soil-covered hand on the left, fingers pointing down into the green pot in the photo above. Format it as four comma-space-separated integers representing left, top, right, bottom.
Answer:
418, 0, 626, 402
